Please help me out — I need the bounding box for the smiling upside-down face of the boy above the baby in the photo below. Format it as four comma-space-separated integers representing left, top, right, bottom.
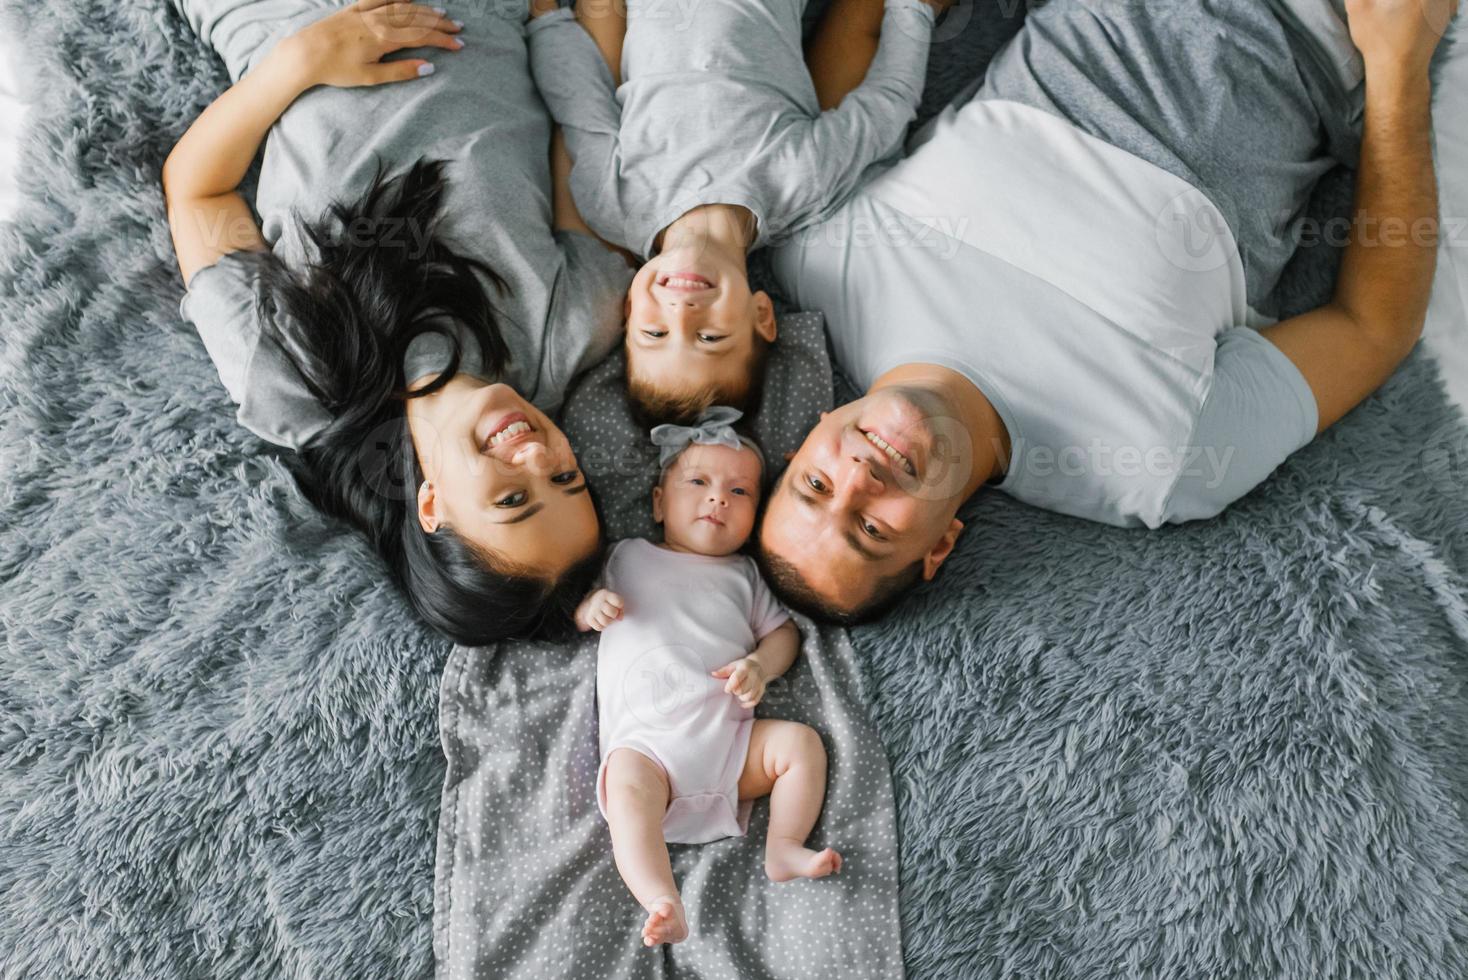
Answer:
627, 248, 775, 404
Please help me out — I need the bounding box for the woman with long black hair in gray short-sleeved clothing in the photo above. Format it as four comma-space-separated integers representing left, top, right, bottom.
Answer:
163, 0, 630, 644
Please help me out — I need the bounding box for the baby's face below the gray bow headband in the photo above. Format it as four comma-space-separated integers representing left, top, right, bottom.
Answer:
652, 443, 760, 556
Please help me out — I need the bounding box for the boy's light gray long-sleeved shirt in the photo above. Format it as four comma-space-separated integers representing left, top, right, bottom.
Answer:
528, 0, 934, 255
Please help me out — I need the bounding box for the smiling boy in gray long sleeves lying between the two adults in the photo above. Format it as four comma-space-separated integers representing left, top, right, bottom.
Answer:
528, 0, 945, 423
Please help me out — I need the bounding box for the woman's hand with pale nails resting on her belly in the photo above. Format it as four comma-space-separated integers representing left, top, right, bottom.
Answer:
273, 0, 464, 88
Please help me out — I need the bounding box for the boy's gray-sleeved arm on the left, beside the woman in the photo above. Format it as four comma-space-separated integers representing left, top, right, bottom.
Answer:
527, 7, 622, 244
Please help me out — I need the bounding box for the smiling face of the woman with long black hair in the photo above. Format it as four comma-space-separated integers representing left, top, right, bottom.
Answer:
407, 374, 600, 578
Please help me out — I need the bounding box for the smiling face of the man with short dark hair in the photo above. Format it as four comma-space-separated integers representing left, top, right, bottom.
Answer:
759, 386, 973, 609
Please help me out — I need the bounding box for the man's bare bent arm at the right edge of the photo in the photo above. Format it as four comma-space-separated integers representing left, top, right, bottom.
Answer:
1261, 0, 1458, 433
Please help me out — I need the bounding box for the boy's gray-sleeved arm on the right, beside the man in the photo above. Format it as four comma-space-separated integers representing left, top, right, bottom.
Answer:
810, 0, 934, 200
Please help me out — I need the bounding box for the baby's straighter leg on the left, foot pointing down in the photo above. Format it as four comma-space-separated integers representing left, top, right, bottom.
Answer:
606, 748, 688, 946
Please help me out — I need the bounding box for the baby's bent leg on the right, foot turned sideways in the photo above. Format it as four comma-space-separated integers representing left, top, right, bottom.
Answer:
738, 719, 841, 882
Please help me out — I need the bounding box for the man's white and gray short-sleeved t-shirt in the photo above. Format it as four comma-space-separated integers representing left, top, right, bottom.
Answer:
774, 0, 1352, 527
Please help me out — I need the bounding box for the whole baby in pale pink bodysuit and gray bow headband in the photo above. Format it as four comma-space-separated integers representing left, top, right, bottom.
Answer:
575, 406, 841, 946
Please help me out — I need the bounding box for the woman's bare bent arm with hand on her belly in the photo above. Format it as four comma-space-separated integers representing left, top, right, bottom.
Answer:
163, 0, 461, 283
